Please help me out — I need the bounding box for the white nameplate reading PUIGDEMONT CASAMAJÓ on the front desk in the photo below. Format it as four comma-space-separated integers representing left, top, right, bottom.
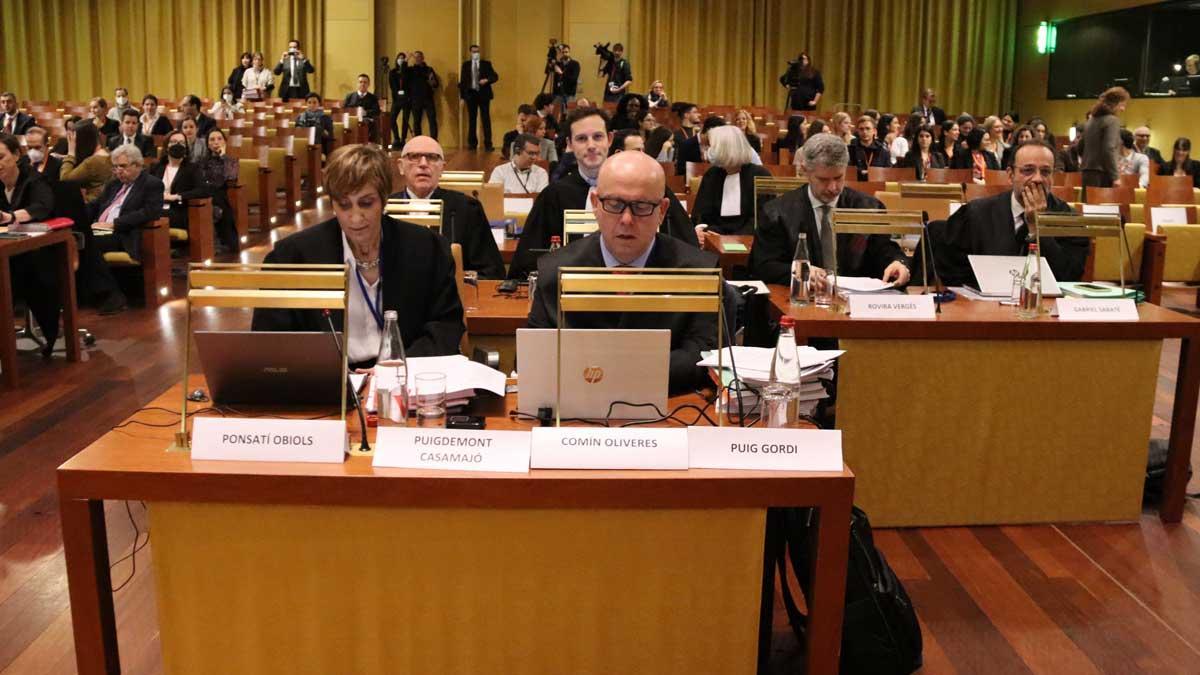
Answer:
372, 426, 529, 473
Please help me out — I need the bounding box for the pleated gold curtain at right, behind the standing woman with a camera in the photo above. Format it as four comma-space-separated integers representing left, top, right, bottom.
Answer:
628, 0, 1018, 115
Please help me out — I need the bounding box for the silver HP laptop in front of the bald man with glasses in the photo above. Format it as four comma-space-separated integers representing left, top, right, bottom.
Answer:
517, 328, 671, 419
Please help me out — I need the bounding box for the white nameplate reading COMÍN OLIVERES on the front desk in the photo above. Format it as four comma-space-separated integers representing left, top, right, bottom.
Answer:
529, 426, 688, 470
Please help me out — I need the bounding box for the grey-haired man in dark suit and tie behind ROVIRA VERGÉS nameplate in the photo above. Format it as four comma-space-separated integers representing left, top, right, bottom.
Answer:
750, 133, 912, 286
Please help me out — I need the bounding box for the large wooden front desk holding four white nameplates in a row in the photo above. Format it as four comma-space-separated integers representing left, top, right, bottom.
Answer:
58, 377, 854, 675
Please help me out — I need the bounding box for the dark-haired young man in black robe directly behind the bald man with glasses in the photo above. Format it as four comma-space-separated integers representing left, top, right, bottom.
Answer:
509, 107, 700, 279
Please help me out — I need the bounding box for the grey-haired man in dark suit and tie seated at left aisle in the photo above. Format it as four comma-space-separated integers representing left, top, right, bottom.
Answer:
88, 145, 162, 315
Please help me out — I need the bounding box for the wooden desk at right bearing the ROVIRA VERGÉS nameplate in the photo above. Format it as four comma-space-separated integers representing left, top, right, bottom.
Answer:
770, 286, 1200, 526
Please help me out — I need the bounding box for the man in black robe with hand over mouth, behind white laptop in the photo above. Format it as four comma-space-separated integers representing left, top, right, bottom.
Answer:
929, 141, 1090, 287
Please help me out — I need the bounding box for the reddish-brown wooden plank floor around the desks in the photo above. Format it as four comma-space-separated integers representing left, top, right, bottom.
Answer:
0, 149, 1200, 675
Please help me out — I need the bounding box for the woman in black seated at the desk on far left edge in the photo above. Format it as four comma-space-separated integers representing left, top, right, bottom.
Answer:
0, 133, 61, 358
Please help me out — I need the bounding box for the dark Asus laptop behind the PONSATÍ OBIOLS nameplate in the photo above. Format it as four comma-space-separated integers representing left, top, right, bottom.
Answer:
196, 330, 346, 405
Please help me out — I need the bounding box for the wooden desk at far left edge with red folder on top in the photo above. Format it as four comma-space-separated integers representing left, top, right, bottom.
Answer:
0, 228, 79, 388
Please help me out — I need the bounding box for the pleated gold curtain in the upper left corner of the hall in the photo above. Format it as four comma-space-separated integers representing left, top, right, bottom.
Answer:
0, 0, 325, 103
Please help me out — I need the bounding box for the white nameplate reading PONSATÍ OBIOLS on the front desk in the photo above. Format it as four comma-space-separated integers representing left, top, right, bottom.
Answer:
192, 417, 349, 464
